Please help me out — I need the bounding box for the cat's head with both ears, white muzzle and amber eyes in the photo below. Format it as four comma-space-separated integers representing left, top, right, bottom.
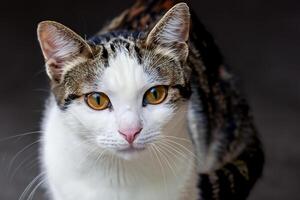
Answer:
38, 3, 190, 159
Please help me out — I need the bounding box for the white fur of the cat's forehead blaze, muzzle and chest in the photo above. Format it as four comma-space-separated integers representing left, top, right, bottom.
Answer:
41, 50, 197, 200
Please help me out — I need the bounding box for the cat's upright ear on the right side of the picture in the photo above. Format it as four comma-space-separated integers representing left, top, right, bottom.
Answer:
146, 3, 190, 59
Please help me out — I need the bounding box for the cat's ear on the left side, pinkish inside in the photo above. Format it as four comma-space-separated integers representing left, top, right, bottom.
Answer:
37, 21, 92, 82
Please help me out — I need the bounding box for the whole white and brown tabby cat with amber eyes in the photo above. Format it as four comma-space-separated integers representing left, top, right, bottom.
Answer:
37, 0, 264, 200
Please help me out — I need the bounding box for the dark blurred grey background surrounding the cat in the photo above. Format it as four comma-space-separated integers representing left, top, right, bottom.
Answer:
0, 0, 300, 200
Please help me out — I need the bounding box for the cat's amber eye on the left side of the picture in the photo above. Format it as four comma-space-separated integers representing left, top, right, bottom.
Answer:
85, 92, 110, 110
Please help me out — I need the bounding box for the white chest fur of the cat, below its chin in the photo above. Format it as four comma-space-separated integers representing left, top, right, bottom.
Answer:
42, 105, 196, 200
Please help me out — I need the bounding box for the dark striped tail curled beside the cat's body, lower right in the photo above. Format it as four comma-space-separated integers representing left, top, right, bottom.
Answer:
199, 141, 264, 200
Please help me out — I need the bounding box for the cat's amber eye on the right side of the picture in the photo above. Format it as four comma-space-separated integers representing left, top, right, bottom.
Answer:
143, 85, 168, 105
